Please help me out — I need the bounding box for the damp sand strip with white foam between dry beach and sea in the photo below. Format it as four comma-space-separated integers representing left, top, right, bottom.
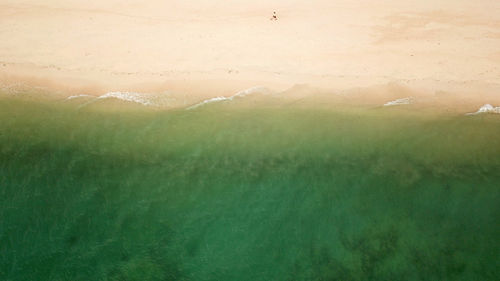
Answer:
0, 72, 500, 115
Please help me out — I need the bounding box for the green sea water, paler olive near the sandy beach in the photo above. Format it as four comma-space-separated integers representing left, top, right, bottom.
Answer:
0, 99, 500, 281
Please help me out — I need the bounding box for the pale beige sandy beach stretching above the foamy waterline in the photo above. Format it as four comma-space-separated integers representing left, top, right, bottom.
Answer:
0, 0, 500, 103
